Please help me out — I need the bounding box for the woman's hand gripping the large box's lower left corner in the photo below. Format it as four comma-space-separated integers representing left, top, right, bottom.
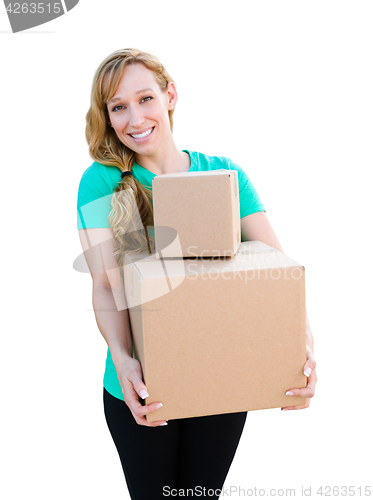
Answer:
118, 357, 167, 427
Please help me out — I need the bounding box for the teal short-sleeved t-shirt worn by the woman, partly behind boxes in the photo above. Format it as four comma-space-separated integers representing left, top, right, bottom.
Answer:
77, 149, 266, 401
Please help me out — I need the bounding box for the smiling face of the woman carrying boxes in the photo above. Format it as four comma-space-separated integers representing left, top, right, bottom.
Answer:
103, 63, 177, 157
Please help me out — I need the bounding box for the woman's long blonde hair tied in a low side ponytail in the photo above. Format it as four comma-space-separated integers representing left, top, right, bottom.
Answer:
85, 48, 174, 278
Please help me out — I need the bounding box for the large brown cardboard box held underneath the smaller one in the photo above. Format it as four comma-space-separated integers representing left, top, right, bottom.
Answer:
124, 241, 307, 422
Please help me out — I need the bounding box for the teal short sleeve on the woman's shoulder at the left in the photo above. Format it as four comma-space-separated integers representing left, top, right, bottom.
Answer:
77, 164, 113, 229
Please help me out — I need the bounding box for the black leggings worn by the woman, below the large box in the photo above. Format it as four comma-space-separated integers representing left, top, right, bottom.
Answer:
104, 388, 247, 500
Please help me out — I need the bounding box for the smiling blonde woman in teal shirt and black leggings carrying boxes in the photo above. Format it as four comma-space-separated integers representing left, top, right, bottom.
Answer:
78, 49, 316, 500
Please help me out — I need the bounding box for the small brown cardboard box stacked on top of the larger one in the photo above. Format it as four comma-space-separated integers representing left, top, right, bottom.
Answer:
152, 169, 241, 258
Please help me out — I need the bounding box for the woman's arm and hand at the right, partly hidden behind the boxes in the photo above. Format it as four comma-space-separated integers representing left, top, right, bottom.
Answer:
241, 212, 317, 410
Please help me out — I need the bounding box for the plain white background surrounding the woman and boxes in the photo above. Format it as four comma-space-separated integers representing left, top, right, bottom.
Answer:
0, 0, 373, 500
